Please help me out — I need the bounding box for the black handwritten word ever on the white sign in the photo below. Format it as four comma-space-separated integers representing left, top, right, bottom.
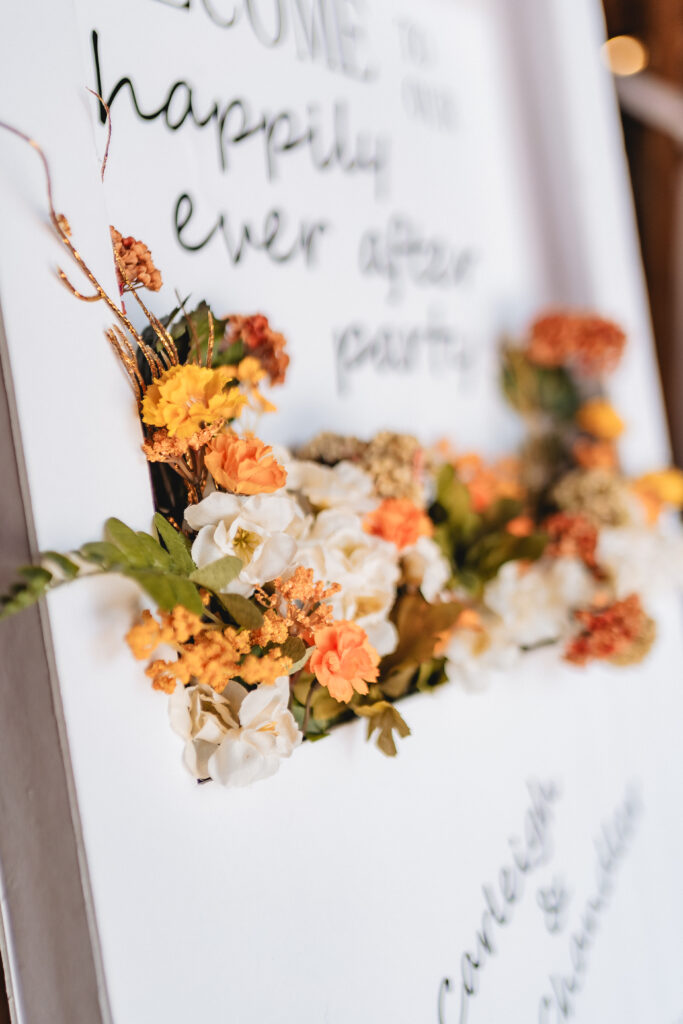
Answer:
174, 193, 329, 267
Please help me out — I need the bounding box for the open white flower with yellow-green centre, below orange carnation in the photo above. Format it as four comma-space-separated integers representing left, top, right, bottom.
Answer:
185, 492, 308, 597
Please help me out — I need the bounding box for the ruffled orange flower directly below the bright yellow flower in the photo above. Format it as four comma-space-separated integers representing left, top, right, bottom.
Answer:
205, 434, 287, 495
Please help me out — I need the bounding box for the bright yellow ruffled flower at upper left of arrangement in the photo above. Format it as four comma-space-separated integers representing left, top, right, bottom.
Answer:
142, 362, 246, 437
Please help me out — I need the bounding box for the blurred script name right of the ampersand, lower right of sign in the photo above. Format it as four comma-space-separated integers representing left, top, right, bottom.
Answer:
539, 791, 641, 1024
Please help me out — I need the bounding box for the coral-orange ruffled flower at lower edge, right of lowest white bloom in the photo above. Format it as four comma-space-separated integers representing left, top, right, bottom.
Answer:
308, 622, 380, 703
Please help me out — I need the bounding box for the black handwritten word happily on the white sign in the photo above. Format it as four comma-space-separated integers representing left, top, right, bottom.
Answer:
91, 31, 389, 195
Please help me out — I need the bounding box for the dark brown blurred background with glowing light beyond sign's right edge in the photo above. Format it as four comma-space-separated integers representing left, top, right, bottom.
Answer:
603, 0, 683, 466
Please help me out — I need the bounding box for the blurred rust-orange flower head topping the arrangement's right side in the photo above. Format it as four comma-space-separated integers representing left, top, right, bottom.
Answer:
526, 313, 626, 377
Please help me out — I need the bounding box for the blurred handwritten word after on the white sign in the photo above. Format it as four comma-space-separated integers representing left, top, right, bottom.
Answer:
358, 213, 475, 298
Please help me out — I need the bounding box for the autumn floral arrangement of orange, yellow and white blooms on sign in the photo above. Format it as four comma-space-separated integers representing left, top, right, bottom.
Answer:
2, 130, 683, 786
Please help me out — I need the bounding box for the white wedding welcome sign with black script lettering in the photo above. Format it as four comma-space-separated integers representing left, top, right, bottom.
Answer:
0, 0, 683, 1024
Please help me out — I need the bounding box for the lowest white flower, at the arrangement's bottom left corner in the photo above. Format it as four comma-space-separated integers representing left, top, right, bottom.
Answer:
170, 676, 302, 787
